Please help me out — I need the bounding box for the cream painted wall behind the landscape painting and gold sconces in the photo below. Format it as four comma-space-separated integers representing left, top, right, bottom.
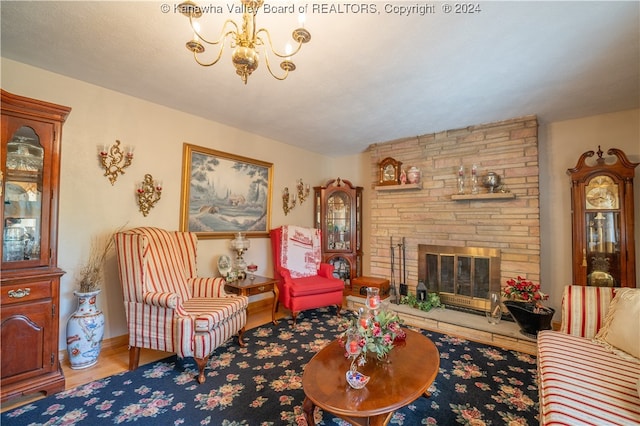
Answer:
2, 58, 368, 349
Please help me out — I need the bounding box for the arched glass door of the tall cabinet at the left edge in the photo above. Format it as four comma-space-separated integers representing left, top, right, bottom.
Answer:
2, 126, 44, 263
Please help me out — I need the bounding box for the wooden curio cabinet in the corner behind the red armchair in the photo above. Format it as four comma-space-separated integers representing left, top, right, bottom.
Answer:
313, 178, 362, 286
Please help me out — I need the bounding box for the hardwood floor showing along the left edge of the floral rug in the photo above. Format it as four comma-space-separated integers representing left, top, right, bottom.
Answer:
0, 301, 287, 412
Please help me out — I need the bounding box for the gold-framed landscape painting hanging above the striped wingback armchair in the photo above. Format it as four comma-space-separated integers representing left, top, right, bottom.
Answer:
180, 143, 273, 238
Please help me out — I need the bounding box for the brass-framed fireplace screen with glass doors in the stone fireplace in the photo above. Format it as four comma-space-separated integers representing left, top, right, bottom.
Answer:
418, 244, 500, 311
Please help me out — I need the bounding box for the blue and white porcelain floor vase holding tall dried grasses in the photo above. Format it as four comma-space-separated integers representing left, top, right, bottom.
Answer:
67, 233, 114, 369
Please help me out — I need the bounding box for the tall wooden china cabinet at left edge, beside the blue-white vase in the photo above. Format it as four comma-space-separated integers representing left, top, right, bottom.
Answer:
0, 90, 71, 401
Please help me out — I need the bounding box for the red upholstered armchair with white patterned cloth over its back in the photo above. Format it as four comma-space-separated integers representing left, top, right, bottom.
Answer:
270, 226, 344, 324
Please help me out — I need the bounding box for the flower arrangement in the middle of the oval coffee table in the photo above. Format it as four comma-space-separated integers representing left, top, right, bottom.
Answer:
341, 308, 406, 365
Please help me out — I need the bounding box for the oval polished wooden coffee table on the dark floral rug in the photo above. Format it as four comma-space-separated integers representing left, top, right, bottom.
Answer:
302, 329, 440, 426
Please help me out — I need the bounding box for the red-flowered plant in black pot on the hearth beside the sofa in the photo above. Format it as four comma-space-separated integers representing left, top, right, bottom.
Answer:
502, 276, 555, 338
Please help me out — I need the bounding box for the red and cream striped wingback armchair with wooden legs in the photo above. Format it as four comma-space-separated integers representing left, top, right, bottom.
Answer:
114, 227, 248, 383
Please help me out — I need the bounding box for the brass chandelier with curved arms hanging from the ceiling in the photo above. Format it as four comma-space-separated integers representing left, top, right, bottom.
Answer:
178, 0, 311, 84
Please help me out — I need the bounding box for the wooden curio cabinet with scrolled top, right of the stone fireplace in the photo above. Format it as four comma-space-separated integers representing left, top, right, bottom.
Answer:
567, 146, 640, 287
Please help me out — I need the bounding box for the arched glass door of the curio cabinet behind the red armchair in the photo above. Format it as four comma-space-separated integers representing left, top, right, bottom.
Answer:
326, 191, 353, 251
